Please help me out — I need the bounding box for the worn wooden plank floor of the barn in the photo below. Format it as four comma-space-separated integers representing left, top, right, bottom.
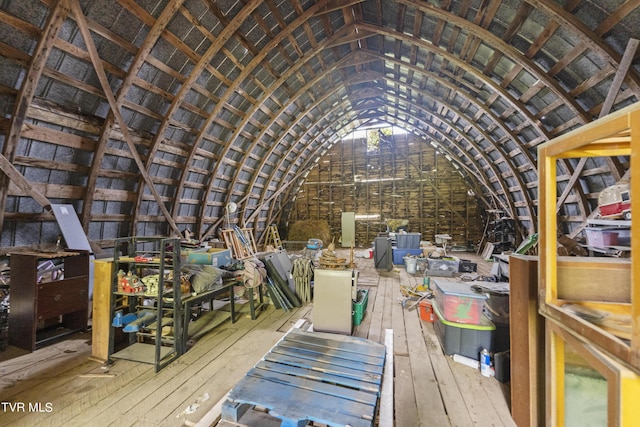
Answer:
0, 254, 515, 427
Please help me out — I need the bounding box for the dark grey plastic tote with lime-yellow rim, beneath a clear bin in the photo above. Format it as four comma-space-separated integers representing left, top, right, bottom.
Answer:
433, 304, 496, 360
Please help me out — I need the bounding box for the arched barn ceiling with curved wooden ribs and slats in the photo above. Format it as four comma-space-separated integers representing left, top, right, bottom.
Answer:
0, 0, 640, 246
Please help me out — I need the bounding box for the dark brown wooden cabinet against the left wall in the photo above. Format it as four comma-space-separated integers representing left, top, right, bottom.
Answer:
9, 251, 89, 351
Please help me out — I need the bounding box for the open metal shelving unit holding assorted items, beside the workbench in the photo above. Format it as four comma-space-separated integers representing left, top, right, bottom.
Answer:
109, 237, 185, 372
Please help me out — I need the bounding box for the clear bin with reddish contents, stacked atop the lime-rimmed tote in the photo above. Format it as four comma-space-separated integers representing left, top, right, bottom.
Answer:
432, 279, 487, 325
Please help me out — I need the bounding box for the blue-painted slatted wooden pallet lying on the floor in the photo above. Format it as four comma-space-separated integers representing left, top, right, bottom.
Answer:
222, 329, 385, 427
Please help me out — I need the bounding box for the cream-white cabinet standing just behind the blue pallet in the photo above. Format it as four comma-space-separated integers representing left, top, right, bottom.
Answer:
312, 268, 358, 335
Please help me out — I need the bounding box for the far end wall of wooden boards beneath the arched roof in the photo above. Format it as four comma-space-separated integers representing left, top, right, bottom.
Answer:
285, 135, 484, 247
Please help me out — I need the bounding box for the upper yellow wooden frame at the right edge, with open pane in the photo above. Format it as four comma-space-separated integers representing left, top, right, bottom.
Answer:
538, 103, 640, 372
